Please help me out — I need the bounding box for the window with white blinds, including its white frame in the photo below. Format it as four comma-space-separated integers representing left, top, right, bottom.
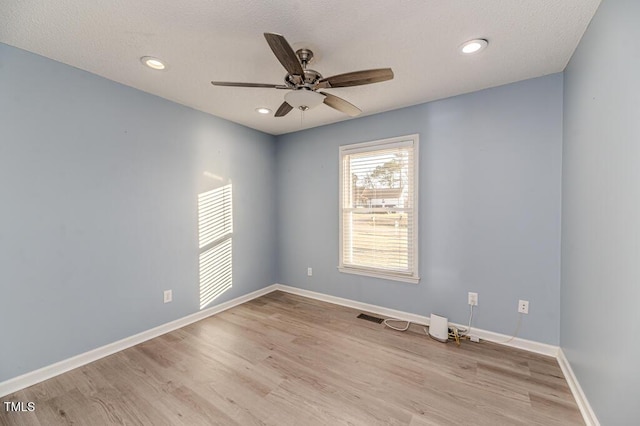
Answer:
338, 134, 419, 283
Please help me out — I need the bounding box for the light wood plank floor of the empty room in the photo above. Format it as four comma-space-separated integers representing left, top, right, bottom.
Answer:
0, 292, 584, 426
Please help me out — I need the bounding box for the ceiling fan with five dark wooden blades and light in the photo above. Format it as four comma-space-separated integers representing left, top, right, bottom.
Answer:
211, 33, 393, 117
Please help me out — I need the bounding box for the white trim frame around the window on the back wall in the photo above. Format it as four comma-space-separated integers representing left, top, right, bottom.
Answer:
338, 133, 420, 284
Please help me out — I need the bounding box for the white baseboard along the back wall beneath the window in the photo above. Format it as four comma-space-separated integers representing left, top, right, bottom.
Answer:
274, 284, 558, 358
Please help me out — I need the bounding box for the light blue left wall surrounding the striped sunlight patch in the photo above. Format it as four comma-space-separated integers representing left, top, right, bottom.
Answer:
0, 44, 276, 382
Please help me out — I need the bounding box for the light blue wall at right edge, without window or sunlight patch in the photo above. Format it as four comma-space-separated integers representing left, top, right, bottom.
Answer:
561, 0, 640, 425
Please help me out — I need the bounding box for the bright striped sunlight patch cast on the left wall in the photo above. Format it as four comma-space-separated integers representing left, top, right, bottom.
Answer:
198, 184, 233, 309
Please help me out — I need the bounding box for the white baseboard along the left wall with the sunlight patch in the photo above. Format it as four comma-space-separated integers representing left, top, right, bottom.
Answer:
0, 284, 277, 397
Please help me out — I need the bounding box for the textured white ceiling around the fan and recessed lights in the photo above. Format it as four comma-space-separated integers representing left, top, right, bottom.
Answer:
0, 0, 600, 134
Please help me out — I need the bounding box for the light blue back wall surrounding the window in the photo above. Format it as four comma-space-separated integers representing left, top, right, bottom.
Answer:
277, 74, 563, 344
